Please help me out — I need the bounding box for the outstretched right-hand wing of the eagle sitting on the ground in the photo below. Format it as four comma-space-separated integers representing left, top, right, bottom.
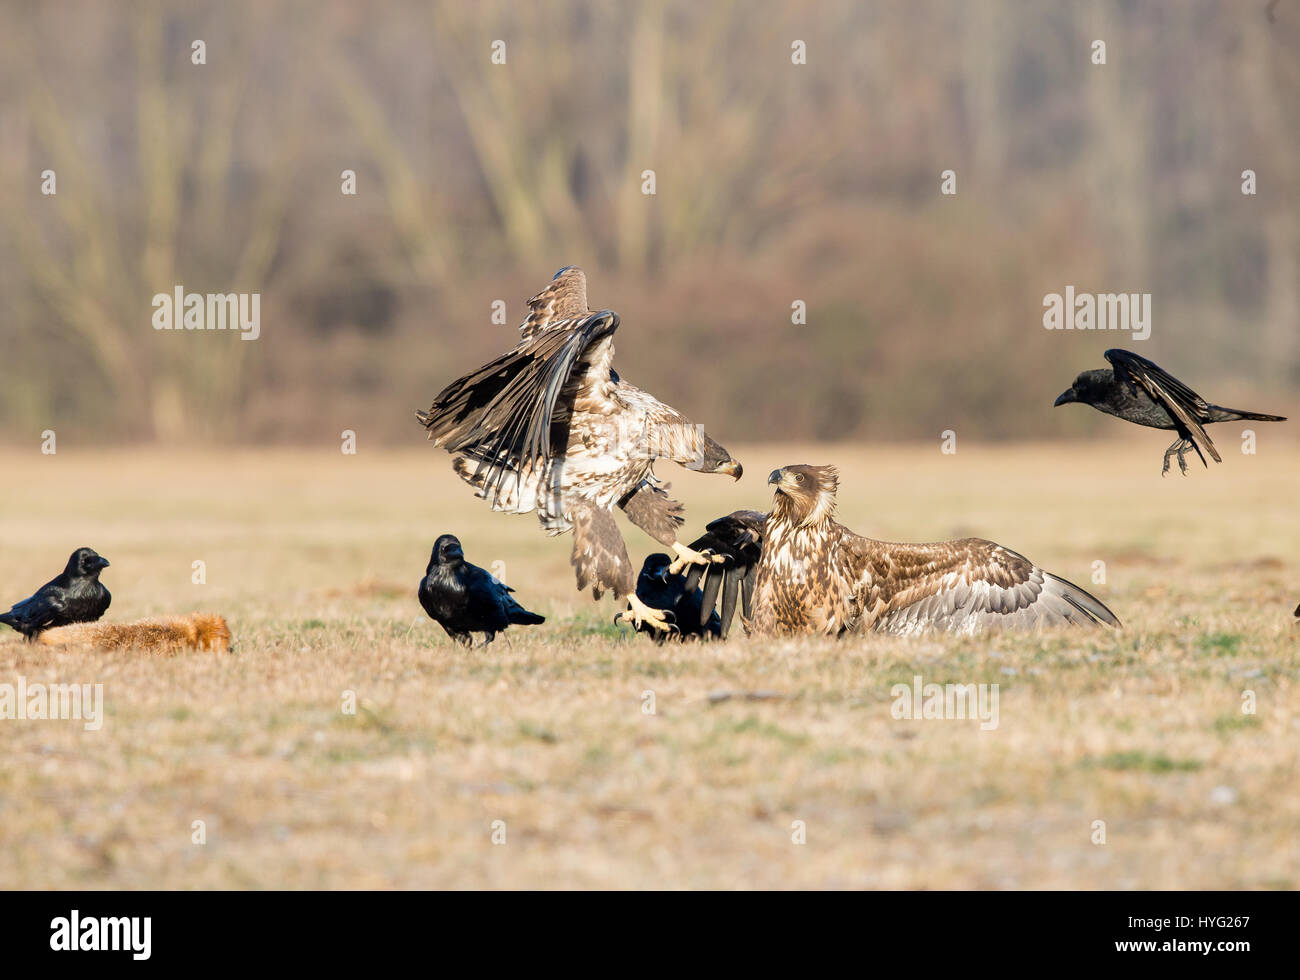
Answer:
832, 534, 1119, 634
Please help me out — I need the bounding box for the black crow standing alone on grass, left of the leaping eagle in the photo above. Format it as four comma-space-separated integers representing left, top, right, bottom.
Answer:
417, 534, 546, 646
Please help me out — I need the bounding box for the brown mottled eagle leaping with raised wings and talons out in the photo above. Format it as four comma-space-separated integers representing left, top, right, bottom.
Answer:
416, 266, 741, 630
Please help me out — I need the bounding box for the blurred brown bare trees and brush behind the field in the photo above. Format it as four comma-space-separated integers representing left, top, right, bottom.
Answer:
0, 0, 1300, 445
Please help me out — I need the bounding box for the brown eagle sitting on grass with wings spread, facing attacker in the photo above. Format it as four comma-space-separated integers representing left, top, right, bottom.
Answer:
688, 465, 1119, 636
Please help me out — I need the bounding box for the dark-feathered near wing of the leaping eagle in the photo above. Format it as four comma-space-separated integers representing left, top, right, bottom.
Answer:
416, 309, 619, 499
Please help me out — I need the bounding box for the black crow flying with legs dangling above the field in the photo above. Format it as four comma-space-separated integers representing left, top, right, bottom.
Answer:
1056, 348, 1286, 476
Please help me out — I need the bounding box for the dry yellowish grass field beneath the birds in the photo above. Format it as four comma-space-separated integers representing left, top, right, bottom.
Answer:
0, 439, 1300, 889
